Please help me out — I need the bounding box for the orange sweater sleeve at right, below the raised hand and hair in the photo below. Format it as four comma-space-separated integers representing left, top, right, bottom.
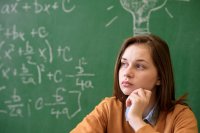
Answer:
136, 105, 198, 133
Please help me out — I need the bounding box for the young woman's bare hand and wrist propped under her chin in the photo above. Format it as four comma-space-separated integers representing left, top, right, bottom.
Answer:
126, 88, 151, 131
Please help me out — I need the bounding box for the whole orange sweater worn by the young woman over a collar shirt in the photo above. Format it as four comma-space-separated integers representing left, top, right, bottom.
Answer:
70, 97, 198, 133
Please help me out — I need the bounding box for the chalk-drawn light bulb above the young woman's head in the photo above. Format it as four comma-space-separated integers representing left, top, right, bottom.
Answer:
120, 0, 167, 35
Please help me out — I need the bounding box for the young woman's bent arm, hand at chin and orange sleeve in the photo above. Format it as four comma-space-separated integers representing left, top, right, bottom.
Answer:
126, 89, 198, 133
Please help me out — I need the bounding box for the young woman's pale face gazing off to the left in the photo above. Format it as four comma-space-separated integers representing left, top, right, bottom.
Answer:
119, 44, 160, 95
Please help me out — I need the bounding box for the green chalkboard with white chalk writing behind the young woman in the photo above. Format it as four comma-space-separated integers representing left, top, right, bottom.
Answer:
0, 0, 200, 133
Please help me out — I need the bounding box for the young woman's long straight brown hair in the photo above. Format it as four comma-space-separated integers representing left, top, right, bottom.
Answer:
113, 34, 186, 111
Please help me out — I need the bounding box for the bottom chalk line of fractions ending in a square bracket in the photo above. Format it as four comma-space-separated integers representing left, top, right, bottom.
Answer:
0, 86, 82, 120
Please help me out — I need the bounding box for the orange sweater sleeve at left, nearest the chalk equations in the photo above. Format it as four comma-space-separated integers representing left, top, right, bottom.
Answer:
70, 100, 108, 133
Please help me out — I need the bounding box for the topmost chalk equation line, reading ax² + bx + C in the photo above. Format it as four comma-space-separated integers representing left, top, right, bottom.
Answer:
0, 0, 76, 15
